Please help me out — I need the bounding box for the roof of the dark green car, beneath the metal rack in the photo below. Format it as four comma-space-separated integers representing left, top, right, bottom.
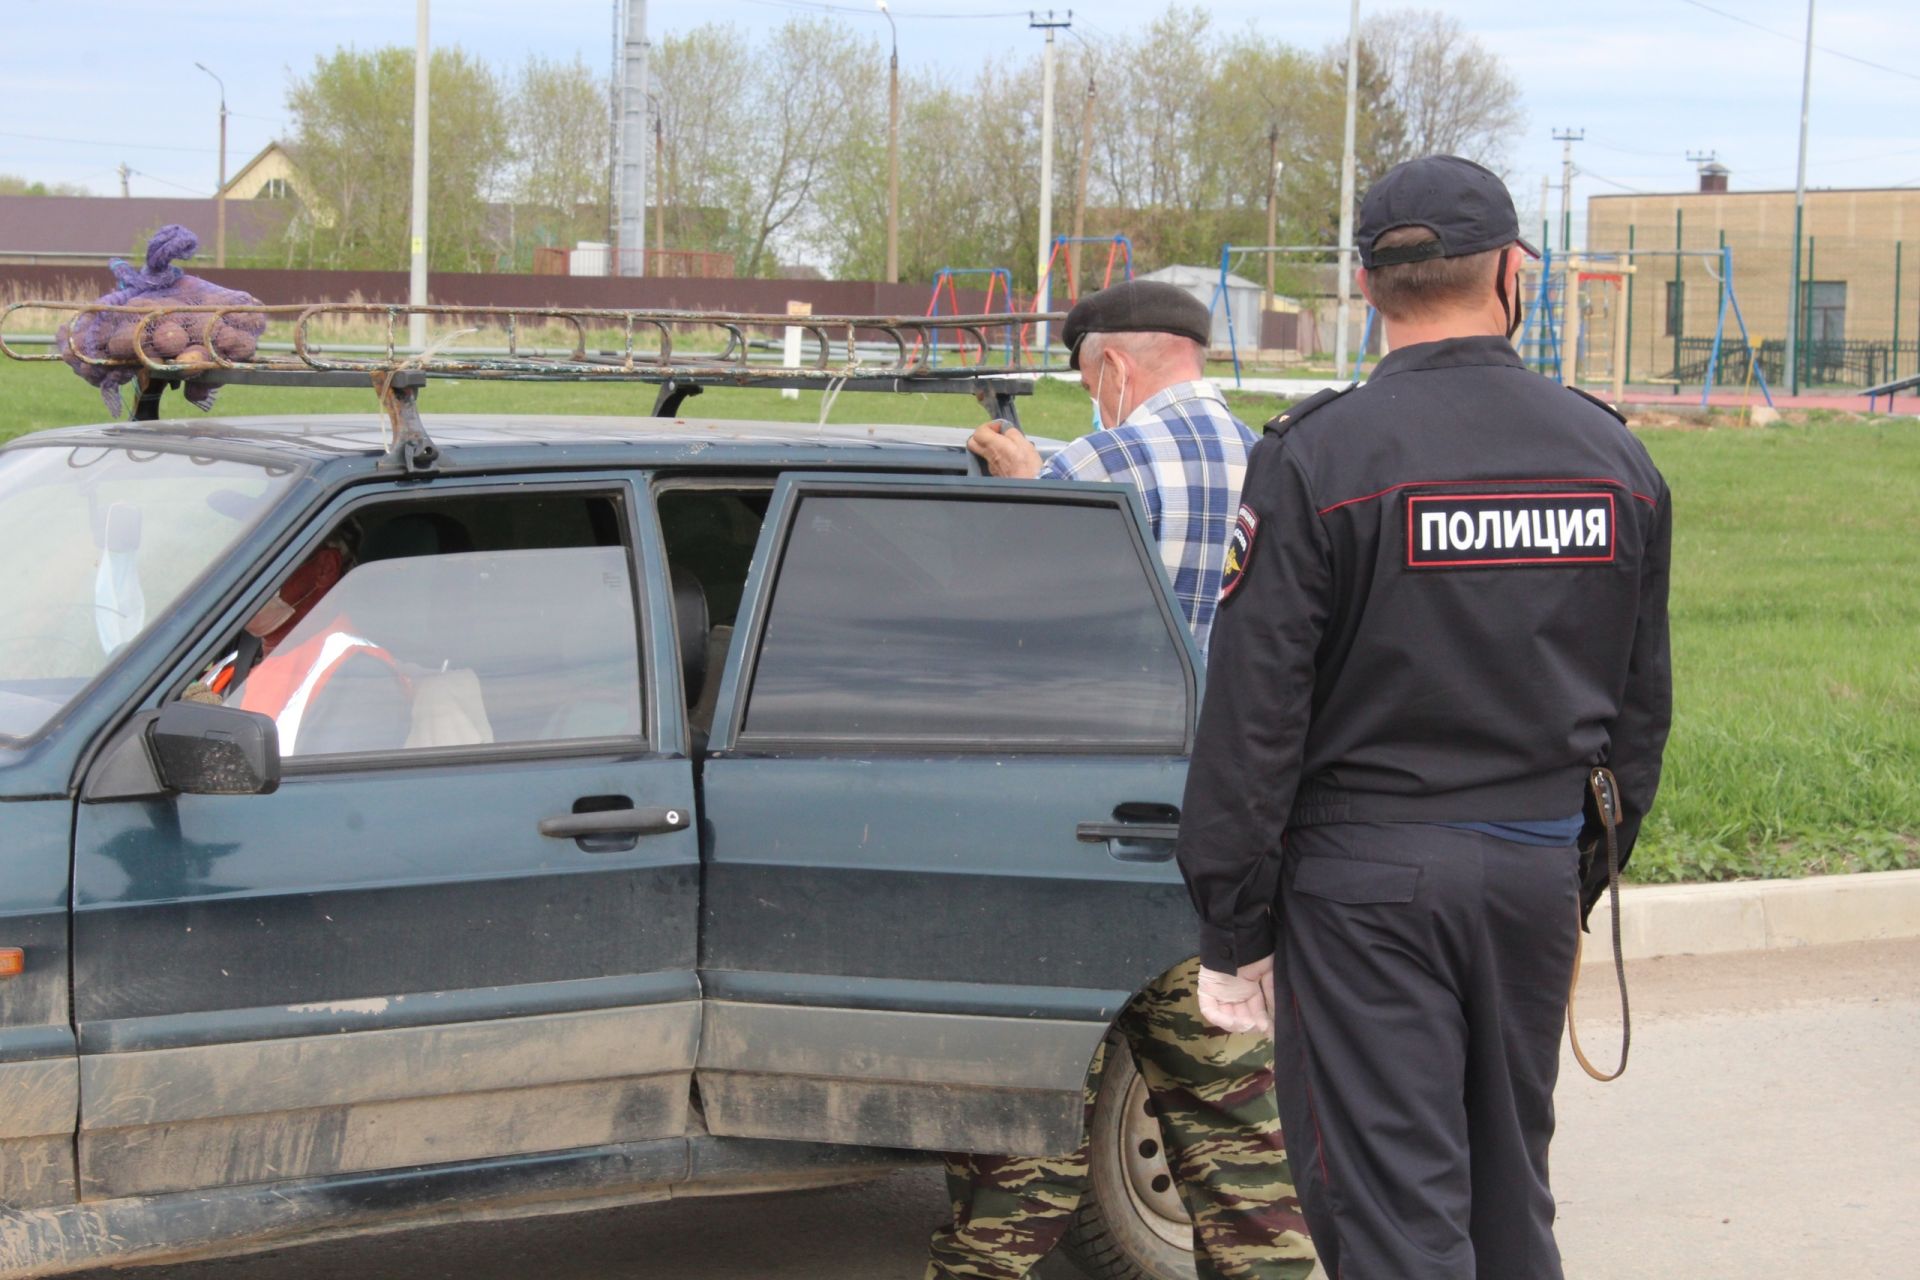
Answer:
11, 413, 1054, 470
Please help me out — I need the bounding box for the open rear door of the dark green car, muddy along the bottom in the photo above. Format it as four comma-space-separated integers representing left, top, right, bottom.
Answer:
697, 476, 1196, 1153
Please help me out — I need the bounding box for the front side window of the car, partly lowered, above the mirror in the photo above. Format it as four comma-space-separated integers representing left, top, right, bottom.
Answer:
184, 495, 641, 758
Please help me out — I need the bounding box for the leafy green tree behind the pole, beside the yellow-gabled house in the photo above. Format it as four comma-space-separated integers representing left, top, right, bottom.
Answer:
282, 46, 513, 271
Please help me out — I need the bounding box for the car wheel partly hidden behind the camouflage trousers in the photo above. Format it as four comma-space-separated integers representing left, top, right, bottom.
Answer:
1066, 1036, 1194, 1280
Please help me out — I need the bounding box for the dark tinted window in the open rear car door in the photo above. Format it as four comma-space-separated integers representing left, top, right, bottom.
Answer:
741, 495, 1188, 750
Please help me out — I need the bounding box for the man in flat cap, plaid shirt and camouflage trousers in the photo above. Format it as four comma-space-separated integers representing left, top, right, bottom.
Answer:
927, 282, 1313, 1280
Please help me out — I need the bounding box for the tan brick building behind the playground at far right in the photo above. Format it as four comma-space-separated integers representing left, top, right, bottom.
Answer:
1588, 175, 1920, 384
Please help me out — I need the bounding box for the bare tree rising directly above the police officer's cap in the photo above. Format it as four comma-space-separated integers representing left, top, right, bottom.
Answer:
1361, 10, 1526, 169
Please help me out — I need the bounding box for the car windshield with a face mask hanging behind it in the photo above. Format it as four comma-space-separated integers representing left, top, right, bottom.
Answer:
0, 445, 292, 739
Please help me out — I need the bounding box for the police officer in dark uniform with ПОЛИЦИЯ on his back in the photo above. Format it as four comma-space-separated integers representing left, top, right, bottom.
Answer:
1177, 155, 1672, 1280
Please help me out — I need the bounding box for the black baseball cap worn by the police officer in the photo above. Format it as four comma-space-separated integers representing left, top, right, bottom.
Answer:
1354, 155, 1540, 271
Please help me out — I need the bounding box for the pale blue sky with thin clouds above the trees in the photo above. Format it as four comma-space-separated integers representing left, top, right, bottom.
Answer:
0, 0, 1920, 249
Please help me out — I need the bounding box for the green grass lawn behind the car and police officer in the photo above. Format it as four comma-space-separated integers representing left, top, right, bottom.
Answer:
0, 361, 1920, 881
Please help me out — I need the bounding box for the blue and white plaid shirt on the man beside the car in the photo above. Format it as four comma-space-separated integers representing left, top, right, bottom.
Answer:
1041, 382, 1254, 656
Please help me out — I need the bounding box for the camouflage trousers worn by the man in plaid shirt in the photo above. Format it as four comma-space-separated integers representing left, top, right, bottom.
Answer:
925, 960, 1313, 1280
